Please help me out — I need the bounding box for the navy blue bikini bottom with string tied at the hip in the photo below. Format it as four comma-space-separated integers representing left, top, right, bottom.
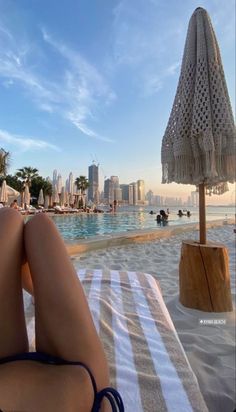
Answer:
0, 352, 125, 412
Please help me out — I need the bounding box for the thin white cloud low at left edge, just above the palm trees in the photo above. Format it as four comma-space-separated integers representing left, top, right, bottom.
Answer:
0, 129, 60, 152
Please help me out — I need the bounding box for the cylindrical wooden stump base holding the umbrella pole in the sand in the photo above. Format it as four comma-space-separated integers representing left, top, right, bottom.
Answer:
179, 240, 233, 312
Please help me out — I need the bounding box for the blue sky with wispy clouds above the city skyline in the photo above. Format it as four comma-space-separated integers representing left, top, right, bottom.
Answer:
0, 0, 235, 203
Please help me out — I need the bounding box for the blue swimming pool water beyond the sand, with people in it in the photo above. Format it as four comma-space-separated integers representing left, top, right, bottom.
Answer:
52, 208, 232, 243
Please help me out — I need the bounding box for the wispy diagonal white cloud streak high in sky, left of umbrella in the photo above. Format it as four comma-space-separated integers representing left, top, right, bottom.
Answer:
42, 29, 116, 142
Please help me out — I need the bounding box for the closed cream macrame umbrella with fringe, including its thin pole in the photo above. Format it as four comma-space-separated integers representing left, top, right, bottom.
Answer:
161, 7, 236, 243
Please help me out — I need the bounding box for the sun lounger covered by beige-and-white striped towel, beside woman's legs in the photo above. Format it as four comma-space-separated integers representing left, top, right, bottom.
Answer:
24, 270, 207, 412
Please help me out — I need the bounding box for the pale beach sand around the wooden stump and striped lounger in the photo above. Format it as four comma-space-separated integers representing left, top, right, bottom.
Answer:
72, 225, 235, 412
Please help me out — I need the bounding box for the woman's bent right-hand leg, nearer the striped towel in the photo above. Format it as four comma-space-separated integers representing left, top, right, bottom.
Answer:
25, 213, 109, 389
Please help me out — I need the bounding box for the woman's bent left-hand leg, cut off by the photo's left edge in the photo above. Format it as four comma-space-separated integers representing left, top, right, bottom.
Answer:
0, 208, 28, 358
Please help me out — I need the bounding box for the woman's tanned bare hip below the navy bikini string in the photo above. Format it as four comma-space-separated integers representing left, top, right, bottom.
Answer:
0, 361, 94, 412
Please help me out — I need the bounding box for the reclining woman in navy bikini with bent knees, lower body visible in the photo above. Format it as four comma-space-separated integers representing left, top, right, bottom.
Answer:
0, 208, 124, 412
